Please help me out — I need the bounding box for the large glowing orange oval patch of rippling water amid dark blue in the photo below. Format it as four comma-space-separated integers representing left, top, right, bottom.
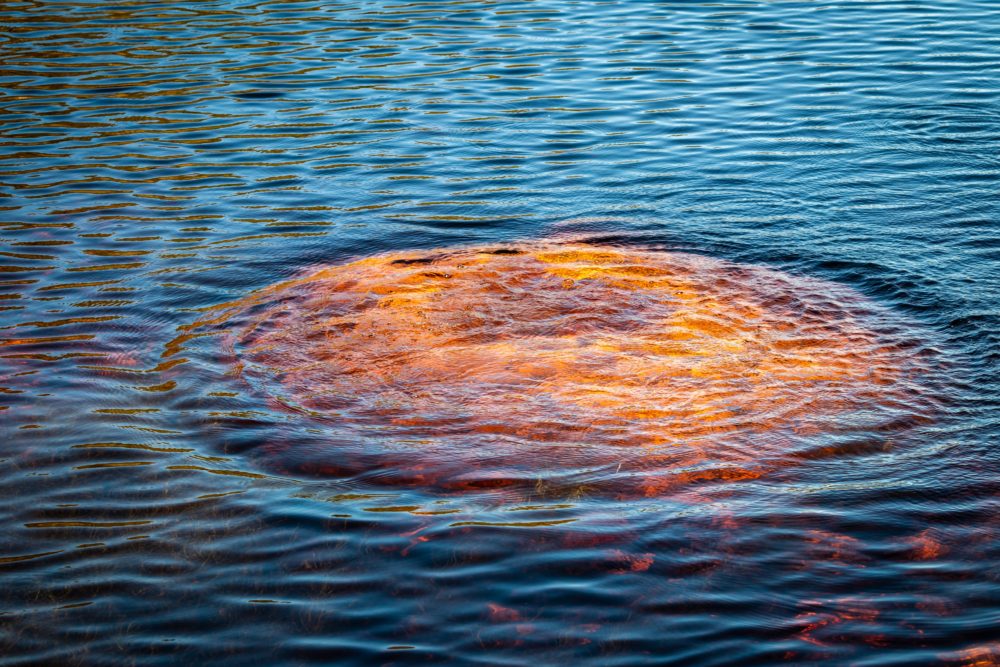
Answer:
191, 243, 927, 496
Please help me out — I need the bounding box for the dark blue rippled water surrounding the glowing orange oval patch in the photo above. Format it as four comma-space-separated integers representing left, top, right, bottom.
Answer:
0, 0, 1000, 665
